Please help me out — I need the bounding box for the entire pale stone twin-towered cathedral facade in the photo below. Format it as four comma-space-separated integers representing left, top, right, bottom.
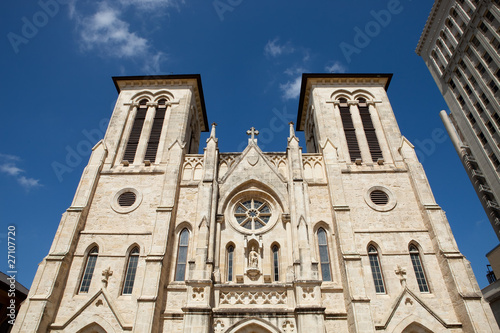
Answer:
13, 74, 499, 333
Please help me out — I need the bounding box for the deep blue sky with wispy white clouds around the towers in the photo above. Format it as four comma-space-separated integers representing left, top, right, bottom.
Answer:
0, 0, 498, 288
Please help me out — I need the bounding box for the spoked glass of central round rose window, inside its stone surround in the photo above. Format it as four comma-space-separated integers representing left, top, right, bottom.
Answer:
234, 199, 271, 230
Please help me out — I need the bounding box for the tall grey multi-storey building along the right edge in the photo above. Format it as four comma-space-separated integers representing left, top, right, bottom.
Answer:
416, 0, 500, 322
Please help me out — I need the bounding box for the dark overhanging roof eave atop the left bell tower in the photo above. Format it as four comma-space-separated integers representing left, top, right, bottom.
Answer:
113, 74, 209, 132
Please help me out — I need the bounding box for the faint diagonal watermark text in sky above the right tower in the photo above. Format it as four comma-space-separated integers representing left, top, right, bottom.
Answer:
339, 0, 412, 63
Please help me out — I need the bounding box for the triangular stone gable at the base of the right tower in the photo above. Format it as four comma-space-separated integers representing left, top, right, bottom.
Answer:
375, 287, 462, 332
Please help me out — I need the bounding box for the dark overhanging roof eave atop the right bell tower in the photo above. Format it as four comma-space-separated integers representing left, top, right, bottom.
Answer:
296, 73, 392, 131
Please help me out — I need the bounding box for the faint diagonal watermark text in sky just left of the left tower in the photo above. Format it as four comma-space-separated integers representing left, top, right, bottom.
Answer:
51, 118, 109, 182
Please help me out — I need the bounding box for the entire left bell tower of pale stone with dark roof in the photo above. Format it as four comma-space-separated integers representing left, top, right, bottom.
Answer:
13, 75, 208, 332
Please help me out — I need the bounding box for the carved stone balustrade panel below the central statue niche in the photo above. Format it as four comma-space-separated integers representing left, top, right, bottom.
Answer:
220, 291, 287, 305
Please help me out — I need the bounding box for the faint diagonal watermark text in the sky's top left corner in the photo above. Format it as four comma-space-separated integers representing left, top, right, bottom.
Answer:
7, 0, 71, 54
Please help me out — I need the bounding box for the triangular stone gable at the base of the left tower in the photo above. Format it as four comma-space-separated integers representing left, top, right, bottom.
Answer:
51, 288, 132, 332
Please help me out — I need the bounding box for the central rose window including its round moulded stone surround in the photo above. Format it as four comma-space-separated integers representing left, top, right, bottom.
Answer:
226, 188, 281, 234
